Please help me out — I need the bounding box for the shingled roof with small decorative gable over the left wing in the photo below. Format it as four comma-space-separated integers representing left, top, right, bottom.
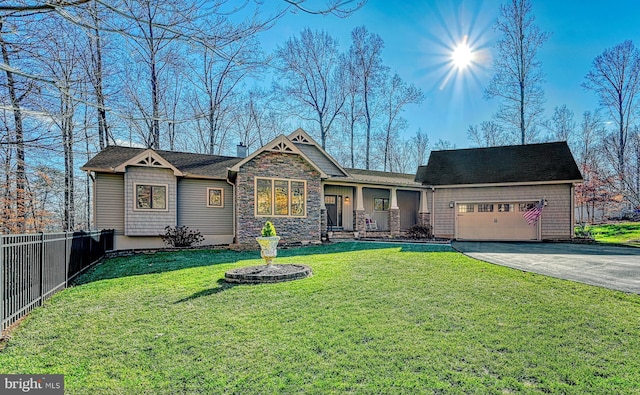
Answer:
81, 145, 242, 179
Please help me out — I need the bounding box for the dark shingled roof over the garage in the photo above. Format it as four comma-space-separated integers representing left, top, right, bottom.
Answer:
415, 141, 582, 186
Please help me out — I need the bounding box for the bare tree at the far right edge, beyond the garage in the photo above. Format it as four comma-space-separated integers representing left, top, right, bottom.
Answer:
582, 41, 640, 180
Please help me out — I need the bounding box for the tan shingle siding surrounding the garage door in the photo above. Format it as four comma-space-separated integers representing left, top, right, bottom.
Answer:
429, 184, 573, 239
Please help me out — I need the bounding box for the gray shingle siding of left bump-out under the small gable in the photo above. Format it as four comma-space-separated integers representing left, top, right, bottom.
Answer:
124, 166, 177, 236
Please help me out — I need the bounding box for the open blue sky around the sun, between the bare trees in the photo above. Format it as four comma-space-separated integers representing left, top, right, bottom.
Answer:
261, 0, 640, 148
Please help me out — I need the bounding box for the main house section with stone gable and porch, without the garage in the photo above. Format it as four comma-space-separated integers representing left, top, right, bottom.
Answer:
82, 129, 427, 249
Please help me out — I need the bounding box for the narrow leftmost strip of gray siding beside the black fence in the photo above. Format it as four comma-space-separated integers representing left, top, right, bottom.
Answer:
93, 173, 124, 235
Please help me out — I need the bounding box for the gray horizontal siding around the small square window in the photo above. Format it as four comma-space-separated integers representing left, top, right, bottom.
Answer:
178, 178, 233, 235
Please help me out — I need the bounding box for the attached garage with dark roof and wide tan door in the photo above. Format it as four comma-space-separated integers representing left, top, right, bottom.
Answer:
416, 142, 582, 240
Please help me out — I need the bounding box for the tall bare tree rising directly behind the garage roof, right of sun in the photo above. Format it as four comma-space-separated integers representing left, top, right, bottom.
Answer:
485, 0, 549, 144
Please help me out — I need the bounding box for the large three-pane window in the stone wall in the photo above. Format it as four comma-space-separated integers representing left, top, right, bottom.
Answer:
255, 178, 307, 217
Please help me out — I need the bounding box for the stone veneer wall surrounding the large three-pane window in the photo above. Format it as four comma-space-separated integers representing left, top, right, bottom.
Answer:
236, 152, 321, 244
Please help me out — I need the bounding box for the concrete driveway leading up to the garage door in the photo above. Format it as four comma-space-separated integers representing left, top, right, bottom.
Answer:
452, 241, 640, 294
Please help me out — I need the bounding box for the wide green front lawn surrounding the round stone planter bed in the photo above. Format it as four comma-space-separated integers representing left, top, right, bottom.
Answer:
0, 243, 640, 394
